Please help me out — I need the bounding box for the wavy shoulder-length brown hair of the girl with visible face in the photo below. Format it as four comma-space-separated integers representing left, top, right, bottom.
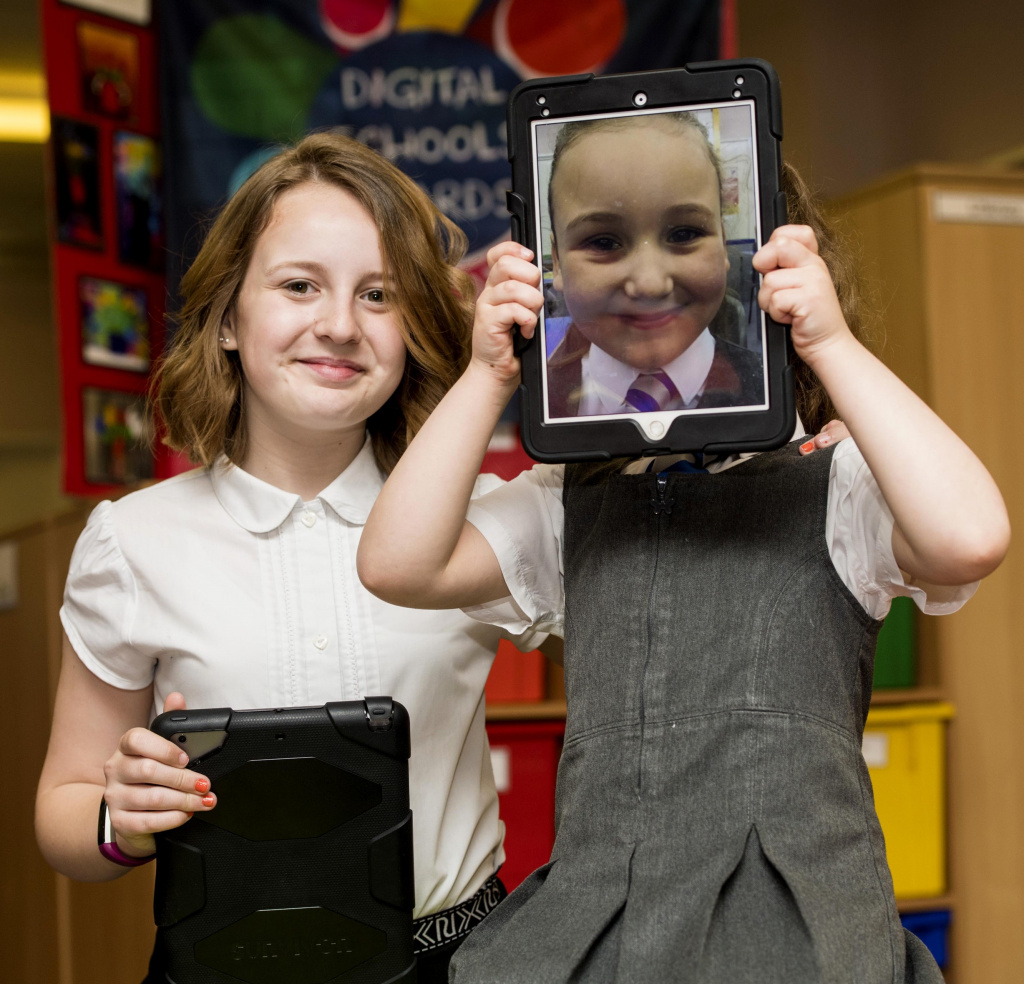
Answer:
152, 132, 475, 474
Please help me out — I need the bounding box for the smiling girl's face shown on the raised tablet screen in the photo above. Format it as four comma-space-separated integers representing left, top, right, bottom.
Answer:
551, 117, 729, 371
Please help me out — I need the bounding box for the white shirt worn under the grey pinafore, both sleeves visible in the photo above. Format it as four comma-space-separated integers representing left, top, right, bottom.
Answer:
465, 424, 979, 636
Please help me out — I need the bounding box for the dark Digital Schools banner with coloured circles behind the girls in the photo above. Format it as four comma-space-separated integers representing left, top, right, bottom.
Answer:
158, 0, 731, 292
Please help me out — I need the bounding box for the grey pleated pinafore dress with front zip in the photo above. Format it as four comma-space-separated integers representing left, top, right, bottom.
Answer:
451, 443, 942, 984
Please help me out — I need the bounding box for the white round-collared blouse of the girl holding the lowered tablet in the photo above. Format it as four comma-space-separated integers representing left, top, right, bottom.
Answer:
60, 441, 544, 916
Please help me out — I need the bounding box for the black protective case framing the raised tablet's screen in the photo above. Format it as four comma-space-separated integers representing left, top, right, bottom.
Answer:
507, 58, 795, 462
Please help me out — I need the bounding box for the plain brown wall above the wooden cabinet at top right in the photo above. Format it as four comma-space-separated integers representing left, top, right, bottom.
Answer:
736, 0, 1024, 197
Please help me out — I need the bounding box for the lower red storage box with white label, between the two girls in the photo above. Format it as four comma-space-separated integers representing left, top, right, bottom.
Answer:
487, 721, 565, 892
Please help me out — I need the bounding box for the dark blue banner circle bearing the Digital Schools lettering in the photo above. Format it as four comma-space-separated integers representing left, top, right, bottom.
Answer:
307, 32, 519, 252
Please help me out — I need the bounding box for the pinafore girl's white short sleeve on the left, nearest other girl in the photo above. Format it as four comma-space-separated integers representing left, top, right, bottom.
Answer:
464, 465, 564, 645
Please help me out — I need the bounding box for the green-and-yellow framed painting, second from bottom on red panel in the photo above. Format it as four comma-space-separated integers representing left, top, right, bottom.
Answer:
78, 276, 150, 373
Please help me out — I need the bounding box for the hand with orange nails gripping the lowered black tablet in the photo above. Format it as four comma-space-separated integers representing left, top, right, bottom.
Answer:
103, 693, 217, 857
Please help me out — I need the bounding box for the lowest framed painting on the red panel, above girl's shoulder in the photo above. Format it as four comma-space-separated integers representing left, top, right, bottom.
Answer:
82, 386, 154, 485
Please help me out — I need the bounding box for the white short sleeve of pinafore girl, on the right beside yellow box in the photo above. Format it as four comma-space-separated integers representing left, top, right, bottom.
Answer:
825, 439, 979, 618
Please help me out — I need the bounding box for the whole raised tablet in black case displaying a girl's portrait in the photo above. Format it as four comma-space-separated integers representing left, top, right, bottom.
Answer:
509, 61, 795, 461
